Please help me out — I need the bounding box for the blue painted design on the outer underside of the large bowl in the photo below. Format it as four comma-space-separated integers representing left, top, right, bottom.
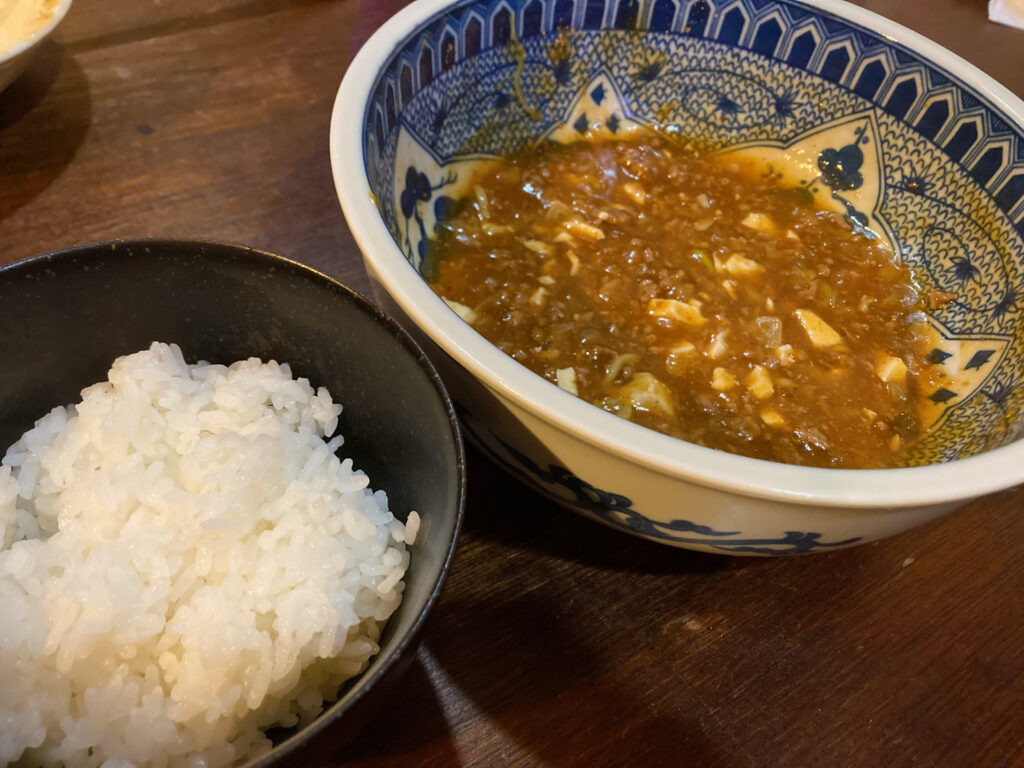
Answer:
456, 404, 861, 555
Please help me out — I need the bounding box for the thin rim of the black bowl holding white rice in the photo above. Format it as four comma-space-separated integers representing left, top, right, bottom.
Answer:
0, 238, 466, 768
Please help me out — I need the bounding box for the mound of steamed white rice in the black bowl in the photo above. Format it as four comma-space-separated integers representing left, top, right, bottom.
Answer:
0, 343, 419, 768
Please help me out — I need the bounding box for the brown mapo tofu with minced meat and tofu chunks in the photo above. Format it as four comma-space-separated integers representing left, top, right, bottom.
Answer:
432, 136, 928, 468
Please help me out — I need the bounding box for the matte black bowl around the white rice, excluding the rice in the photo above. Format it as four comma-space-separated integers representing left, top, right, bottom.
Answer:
0, 240, 465, 766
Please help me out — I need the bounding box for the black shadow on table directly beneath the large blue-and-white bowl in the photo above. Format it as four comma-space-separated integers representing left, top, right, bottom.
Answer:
464, 445, 751, 573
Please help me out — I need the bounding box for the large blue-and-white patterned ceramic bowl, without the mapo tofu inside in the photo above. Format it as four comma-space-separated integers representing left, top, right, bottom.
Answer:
331, 0, 1024, 554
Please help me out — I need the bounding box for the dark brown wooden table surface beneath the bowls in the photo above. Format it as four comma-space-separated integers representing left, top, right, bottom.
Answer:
0, 0, 1024, 768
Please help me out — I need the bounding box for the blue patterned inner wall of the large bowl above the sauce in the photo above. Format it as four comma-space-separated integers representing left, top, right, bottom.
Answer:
364, 0, 1024, 464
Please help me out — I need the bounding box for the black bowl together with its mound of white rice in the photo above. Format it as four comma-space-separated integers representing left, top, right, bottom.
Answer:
0, 241, 465, 768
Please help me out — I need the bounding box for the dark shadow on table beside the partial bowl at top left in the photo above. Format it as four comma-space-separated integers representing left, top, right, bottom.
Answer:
0, 41, 91, 221
